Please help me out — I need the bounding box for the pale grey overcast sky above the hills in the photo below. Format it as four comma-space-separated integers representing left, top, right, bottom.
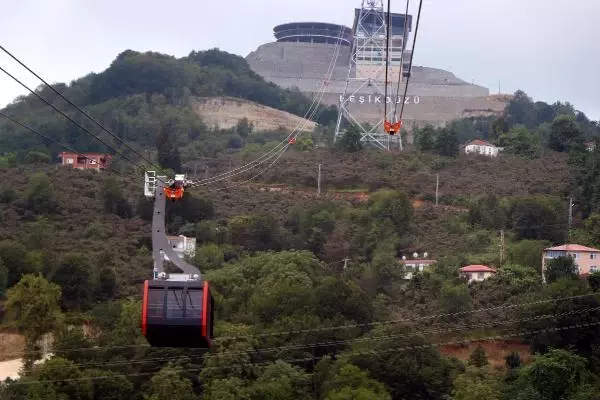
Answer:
0, 0, 600, 120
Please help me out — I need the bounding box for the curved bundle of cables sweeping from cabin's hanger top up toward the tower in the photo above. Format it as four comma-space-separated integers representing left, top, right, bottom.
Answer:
192, 31, 341, 186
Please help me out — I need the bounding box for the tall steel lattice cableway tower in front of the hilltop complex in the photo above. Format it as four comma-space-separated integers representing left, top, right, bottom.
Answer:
334, 0, 409, 150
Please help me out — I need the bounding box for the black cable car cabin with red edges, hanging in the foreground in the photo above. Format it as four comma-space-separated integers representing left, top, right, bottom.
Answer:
142, 280, 214, 348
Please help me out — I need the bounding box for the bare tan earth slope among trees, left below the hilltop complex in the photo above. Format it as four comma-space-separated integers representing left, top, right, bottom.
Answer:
192, 97, 317, 131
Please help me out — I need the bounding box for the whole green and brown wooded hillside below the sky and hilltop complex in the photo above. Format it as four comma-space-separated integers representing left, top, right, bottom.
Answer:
0, 46, 600, 400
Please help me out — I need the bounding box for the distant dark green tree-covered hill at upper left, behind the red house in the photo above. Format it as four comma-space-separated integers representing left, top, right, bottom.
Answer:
0, 49, 337, 160
